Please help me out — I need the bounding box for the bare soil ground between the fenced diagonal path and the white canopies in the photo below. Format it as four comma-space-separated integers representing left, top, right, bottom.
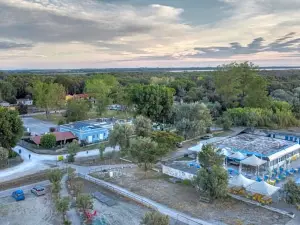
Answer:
102, 168, 290, 225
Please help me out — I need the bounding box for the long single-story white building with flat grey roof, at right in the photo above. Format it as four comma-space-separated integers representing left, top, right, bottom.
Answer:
214, 130, 300, 169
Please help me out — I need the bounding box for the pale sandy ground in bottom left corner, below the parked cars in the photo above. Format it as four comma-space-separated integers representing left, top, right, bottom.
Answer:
0, 194, 62, 225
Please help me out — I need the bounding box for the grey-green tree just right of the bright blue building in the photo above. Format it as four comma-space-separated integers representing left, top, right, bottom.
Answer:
108, 124, 133, 151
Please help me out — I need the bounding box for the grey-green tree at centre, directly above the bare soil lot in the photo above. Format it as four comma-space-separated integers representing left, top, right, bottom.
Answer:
129, 137, 164, 171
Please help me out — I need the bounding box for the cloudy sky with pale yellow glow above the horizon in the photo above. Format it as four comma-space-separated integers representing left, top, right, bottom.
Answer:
0, 0, 300, 69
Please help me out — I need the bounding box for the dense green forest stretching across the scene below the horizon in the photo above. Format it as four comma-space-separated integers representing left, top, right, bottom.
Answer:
0, 62, 300, 128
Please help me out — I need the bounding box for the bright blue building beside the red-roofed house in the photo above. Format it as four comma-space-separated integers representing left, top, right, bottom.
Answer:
59, 121, 109, 143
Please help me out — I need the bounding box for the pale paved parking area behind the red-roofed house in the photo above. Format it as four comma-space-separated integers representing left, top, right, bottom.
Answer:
22, 117, 57, 135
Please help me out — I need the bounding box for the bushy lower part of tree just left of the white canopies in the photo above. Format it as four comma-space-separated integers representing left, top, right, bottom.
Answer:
193, 165, 228, 199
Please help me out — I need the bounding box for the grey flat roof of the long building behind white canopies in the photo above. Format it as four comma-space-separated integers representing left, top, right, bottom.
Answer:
214, 133, 297, 157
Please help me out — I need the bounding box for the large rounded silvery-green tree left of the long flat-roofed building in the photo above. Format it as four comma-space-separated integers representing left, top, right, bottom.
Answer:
174, 103, 211, 139
